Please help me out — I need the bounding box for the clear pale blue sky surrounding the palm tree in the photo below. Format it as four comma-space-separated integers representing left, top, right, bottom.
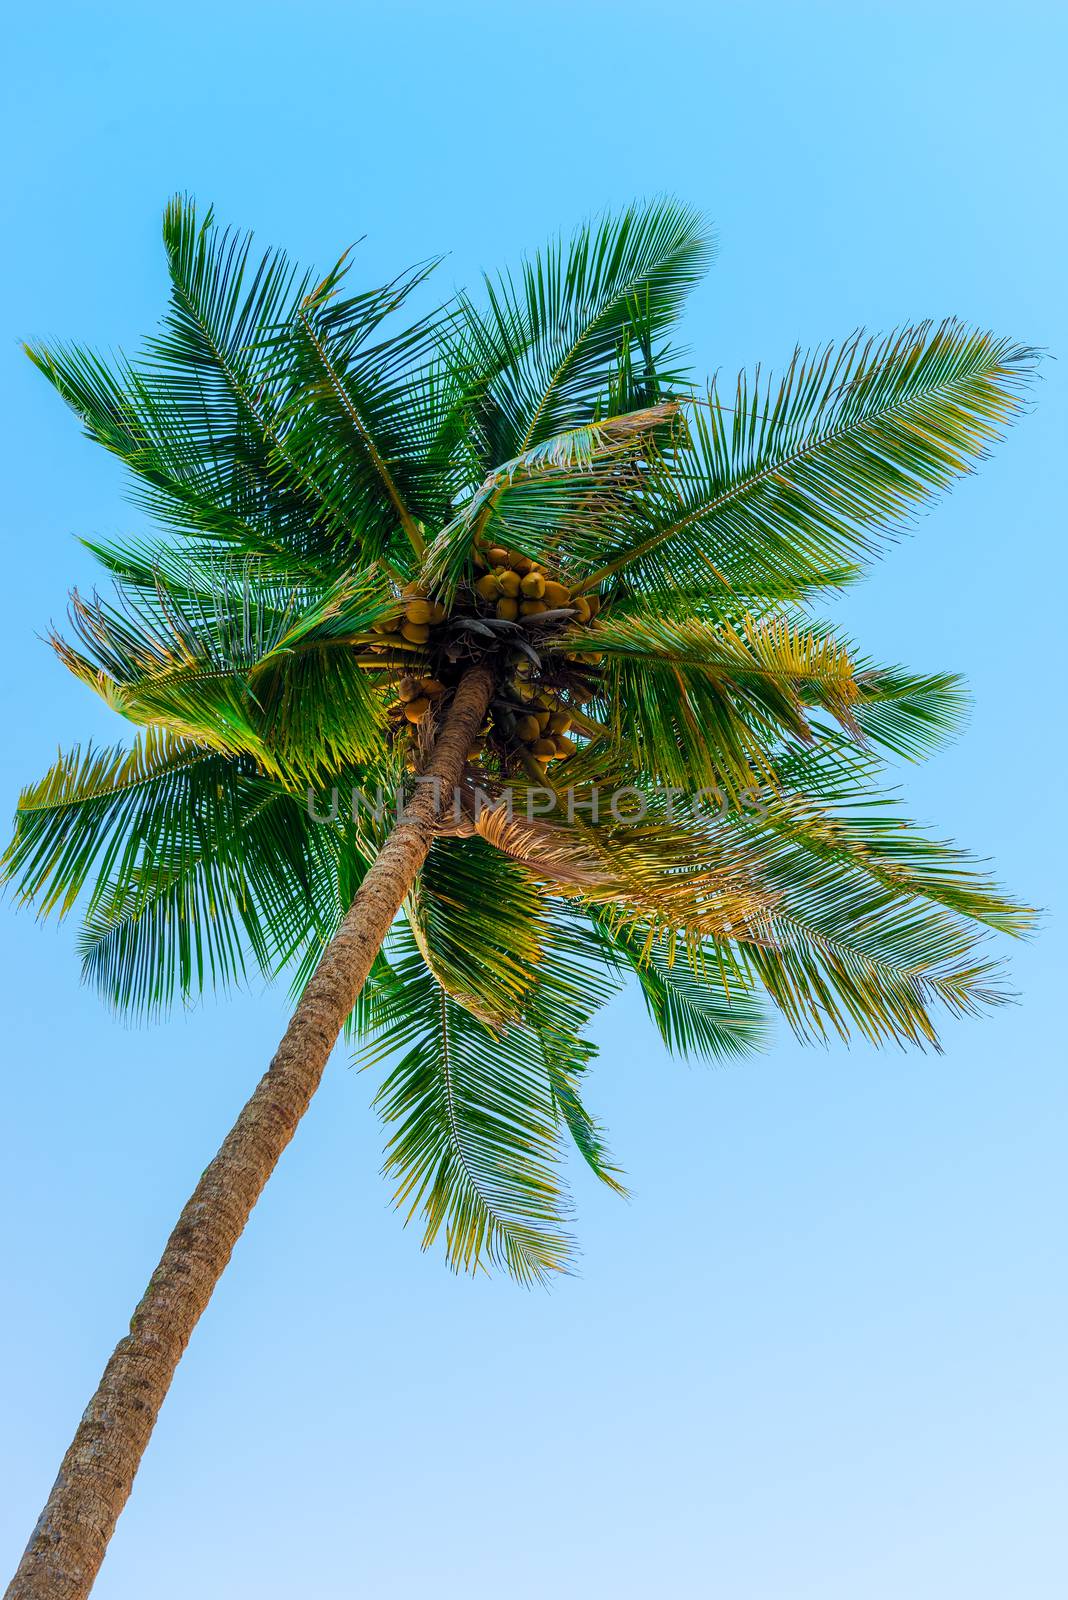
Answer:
0, 0, 1068, 1600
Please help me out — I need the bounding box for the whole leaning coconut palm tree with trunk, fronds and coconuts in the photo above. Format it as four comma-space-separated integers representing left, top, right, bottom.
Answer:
5, 200, 1033, 1600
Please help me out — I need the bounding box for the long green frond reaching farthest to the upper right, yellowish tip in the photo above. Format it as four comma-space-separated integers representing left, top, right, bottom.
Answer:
572, 322, 1034, 597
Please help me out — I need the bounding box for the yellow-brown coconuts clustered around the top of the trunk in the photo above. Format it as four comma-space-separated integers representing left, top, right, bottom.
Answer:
371, 544, 600, 776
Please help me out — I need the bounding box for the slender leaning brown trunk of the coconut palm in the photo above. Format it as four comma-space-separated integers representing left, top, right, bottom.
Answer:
5, 667, 492, 1600
